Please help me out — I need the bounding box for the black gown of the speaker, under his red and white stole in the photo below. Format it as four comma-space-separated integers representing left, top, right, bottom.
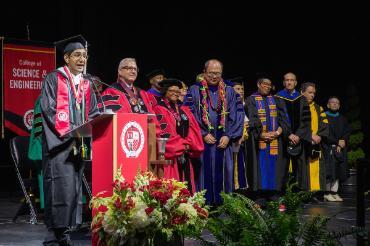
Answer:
40, 70, 99, 229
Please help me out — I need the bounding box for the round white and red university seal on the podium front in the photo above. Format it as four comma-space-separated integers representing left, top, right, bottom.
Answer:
120, 121, 145, 158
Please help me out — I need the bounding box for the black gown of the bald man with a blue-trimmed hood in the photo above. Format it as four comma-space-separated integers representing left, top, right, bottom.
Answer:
275, 95, 312, 186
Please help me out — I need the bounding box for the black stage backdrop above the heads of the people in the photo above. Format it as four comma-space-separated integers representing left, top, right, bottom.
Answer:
0, 4, 370, 194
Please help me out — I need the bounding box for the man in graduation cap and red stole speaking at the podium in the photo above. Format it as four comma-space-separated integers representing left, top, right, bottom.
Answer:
40, 37, 99, 245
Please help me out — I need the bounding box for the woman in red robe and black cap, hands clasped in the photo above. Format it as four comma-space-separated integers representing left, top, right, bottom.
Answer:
153, 79, 204, 192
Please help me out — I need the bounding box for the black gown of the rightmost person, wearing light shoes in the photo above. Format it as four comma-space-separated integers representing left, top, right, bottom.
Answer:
323, 114, 351, 181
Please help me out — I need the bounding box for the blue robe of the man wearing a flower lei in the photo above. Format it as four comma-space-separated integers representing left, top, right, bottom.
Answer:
185, 83, 245, 204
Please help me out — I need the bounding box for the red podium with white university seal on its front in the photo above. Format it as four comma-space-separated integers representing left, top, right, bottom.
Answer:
67, 113, 156, 196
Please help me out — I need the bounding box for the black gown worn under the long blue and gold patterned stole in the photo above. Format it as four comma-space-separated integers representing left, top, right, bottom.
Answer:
246, 93, 287, 191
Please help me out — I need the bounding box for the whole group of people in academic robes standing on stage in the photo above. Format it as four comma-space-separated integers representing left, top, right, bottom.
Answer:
35, 38, 351, 245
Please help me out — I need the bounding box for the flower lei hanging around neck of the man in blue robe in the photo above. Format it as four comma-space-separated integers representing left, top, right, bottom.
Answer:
200, 80, 227, 132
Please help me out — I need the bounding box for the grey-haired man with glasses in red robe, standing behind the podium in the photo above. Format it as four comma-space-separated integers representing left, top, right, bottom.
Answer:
99, 58, 153, 114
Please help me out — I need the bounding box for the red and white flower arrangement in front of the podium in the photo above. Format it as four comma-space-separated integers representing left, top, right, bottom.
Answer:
91, 170, 208, 245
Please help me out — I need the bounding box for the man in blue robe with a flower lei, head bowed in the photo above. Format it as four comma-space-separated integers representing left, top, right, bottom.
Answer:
186, 59, 245, 205
